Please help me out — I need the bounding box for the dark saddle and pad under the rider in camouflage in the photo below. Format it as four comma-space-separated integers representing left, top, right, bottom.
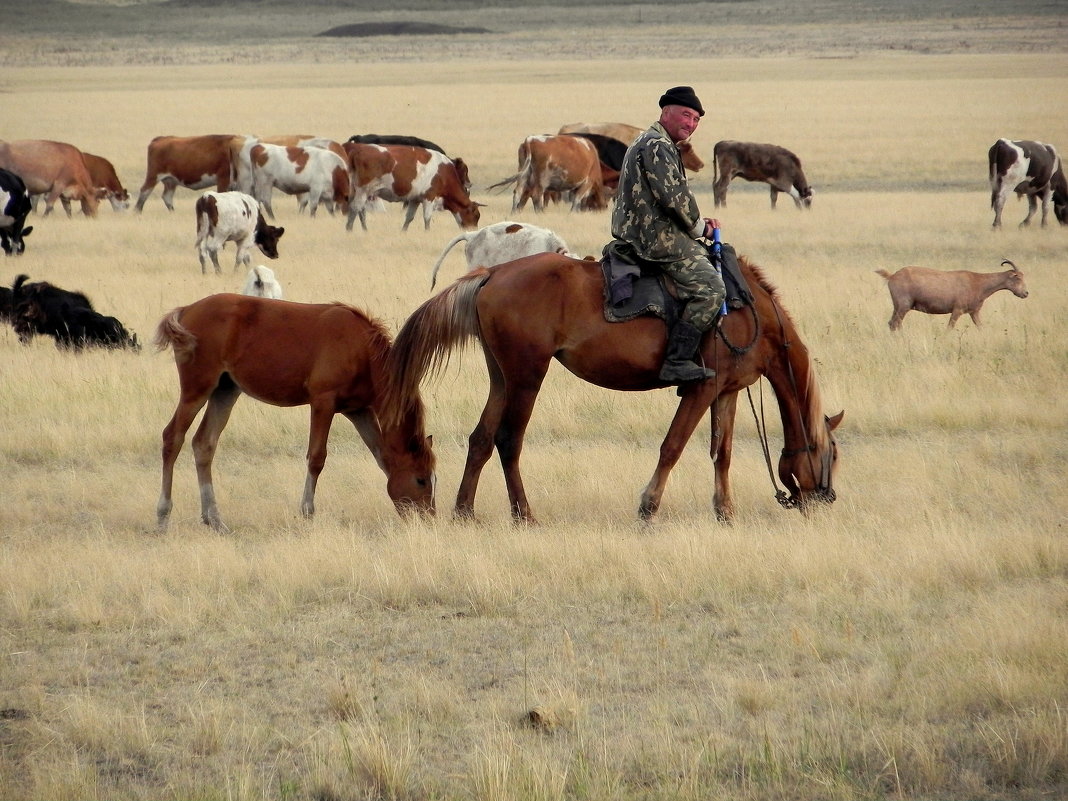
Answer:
601, 239, 753, 326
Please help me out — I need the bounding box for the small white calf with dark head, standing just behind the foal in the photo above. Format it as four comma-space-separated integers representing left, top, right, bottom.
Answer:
197, 191, 285, 274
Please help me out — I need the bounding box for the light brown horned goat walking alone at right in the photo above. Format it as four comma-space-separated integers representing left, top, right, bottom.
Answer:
876, 258, 1027, 331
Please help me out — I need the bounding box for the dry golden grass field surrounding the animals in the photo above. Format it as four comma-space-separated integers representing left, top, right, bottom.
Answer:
0, 3, 1068, 801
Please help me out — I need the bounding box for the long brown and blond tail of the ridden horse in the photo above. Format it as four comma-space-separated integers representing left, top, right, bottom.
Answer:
383, 267, 489, 429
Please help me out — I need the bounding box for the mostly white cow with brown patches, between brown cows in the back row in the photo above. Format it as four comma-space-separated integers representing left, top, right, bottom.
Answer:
249, 142, 352, 219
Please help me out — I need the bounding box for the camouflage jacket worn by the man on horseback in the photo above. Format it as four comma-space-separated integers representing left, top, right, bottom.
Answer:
612, 123, 705, 262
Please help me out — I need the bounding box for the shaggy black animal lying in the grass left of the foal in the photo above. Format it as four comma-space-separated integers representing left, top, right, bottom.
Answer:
11, 274, 141, 350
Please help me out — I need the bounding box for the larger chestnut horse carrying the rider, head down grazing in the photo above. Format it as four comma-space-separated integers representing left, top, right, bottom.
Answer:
389, 253, 843, 522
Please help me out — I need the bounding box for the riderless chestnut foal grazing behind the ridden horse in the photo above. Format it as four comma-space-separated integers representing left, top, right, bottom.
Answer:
156, 294, 435, 531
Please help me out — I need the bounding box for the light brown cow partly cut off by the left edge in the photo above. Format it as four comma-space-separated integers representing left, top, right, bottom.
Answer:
0, 139, 99, 217
